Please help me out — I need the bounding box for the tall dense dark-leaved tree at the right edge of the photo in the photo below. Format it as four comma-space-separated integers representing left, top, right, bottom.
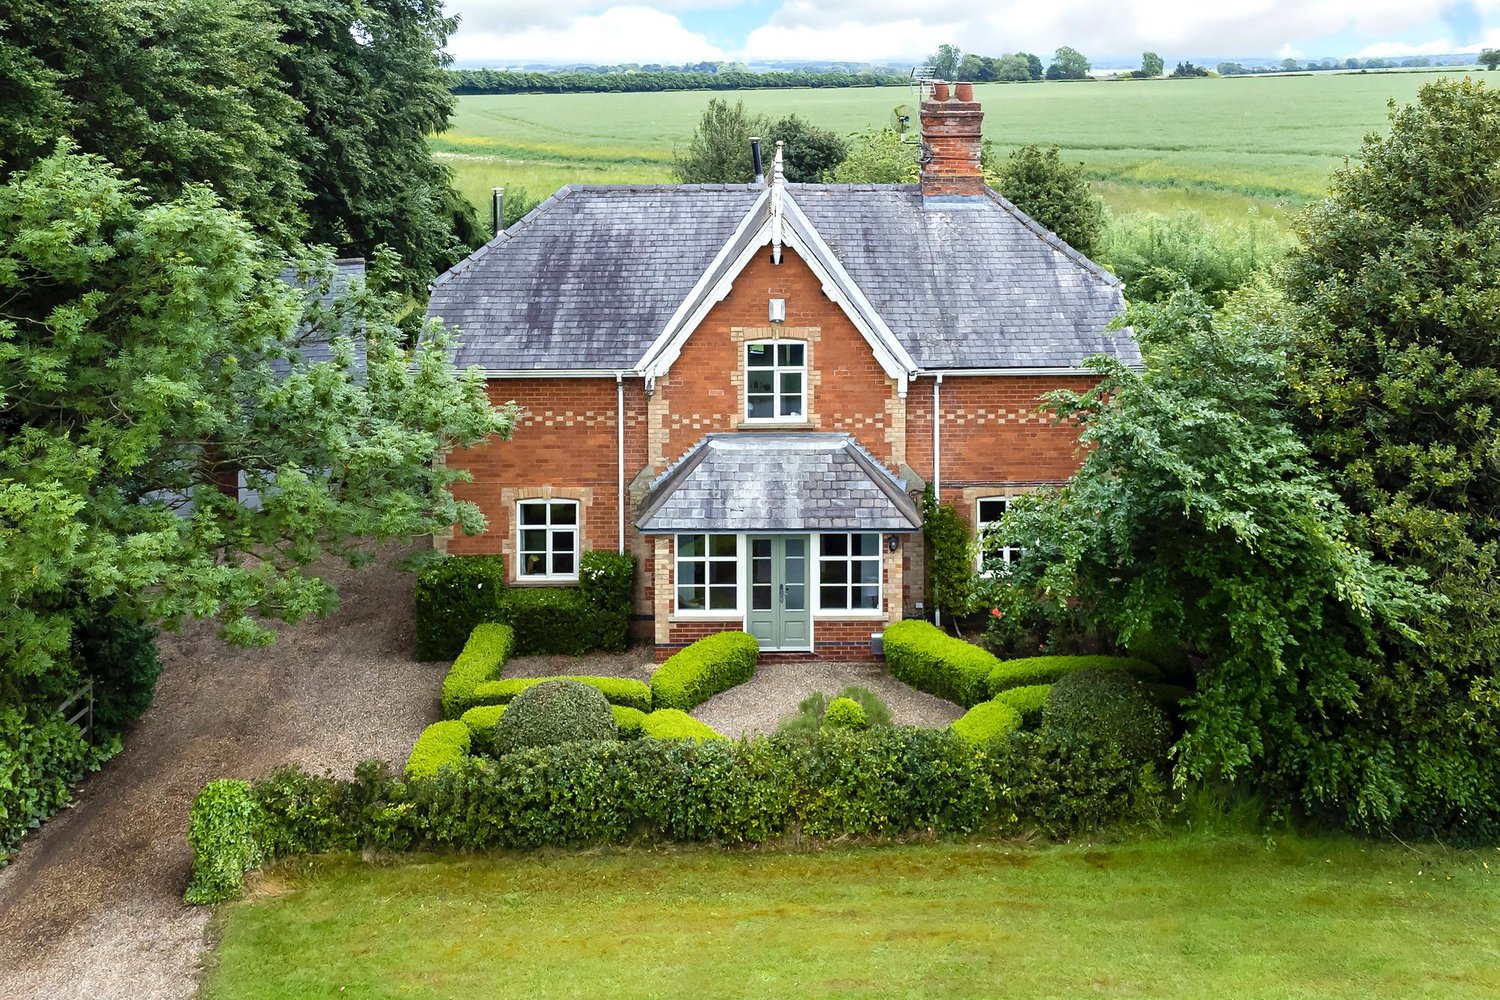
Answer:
1289, 81, 1500, 835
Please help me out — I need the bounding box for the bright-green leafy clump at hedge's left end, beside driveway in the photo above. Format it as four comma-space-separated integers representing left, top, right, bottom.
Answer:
183, 778, 267, 903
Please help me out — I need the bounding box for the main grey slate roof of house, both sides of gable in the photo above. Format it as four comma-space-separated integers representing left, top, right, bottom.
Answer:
428, 184, 1140, 370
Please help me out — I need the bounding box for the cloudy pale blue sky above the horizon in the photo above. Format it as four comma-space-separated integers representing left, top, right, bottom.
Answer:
447, 0, 1500, 66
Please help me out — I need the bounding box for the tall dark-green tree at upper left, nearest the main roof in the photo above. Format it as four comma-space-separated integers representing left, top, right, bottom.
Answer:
267, 0, 483, 295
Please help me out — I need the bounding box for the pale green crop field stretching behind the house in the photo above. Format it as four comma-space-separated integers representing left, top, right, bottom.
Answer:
434, 70, 1484, 219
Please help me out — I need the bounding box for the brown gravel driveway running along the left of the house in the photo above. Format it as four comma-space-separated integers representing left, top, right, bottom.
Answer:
0, 552, 447, 1000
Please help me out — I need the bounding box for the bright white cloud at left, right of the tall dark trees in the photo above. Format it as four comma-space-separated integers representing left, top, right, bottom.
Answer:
449, 7, 729, 66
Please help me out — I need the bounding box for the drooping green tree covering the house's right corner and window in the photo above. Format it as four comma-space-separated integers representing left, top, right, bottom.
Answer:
992, 285, 1434, 828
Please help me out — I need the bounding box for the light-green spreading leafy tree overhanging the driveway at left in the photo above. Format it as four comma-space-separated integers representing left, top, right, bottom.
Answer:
0, 148, 512, 706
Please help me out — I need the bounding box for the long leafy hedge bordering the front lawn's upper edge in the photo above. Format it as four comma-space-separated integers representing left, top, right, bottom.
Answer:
189, 723, 1161, 903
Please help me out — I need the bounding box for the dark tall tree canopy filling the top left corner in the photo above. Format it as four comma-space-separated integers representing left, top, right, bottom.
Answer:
0, 0, 480, 295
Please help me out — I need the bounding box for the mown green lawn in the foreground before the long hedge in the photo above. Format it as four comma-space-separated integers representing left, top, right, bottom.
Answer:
204, 837, 1500, 1000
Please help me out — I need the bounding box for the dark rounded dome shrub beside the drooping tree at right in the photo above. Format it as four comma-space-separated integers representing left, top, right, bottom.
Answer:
1043, 669, 1170, 763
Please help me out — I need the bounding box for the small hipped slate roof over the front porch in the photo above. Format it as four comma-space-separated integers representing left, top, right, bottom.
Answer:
636, 432, 921, 534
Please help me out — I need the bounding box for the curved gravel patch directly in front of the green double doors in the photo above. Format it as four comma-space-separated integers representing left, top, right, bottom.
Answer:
693, 663, 963, 736
